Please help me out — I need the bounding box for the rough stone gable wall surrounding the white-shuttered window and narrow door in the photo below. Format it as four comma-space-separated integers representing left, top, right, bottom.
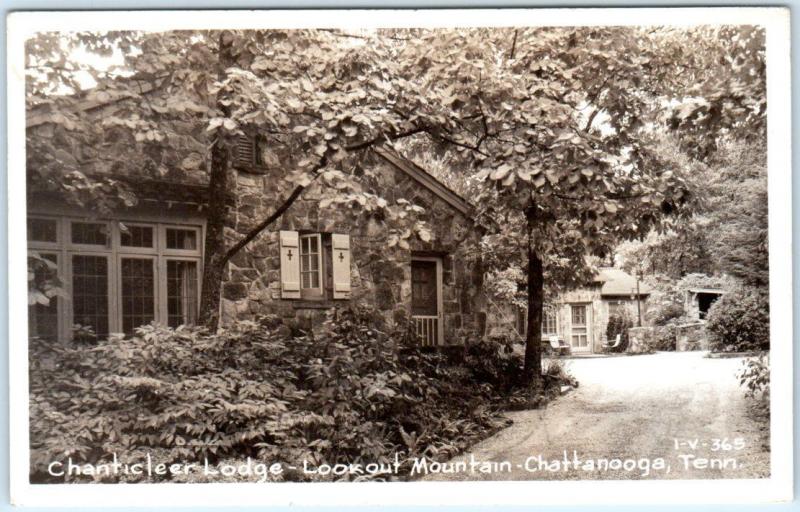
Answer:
221, 150, 485, 343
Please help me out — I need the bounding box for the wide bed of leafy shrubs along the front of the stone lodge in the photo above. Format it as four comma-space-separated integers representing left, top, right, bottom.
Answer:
30, 309, 548, 482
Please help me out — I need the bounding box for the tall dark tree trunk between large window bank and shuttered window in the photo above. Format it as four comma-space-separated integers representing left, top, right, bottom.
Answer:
199, 32, 234, 331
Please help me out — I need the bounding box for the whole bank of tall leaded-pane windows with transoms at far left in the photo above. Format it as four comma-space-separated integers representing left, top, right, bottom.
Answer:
28, 216, 202, 339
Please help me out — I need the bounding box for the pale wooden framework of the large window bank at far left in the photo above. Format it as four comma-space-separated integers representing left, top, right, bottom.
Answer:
27, 214, 205, 341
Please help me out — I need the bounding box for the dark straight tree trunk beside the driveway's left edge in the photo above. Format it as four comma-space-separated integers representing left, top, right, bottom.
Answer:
524, 207, 544, 384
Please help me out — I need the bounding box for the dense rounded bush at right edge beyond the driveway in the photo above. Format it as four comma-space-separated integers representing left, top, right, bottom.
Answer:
706, 288, 769, 352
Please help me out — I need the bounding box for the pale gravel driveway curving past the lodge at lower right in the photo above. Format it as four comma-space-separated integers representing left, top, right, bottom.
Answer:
416, 352, 769, 480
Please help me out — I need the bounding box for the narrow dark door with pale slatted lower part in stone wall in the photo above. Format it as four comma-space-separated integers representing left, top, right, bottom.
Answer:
411, 258, 444, 346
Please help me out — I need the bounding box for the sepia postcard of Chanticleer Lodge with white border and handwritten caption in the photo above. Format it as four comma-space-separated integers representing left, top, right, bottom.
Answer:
9, 9, 792, 503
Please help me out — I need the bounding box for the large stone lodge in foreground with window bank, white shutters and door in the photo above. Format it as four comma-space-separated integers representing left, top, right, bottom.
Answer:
27, 89, 485, 345
